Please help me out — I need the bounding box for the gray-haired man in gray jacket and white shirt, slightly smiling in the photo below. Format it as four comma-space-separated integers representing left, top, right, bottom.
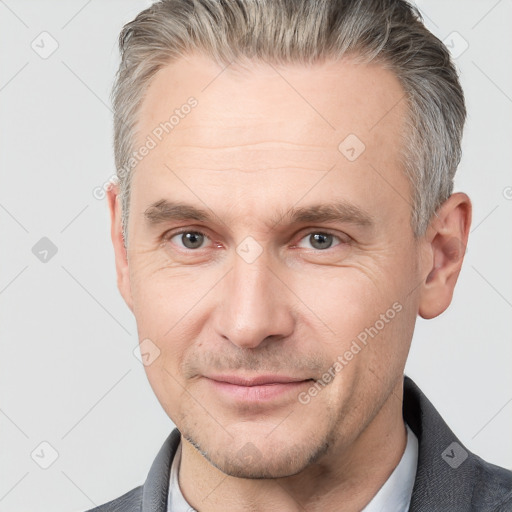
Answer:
95, 0, 512, 512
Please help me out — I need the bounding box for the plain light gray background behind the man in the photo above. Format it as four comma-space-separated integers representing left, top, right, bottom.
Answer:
0, 0, 512, 512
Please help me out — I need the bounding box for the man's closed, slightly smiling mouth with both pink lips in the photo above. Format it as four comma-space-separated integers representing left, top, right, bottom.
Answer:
201, 375, 313, 403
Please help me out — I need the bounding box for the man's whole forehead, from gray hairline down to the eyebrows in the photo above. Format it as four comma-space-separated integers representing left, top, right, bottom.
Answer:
132, 55, 409, 232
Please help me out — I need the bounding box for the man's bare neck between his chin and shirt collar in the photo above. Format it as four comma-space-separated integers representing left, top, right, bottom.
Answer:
179, 380, 407, 512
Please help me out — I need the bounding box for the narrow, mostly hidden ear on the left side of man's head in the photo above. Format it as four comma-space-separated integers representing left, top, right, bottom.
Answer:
107, 184, 133, 312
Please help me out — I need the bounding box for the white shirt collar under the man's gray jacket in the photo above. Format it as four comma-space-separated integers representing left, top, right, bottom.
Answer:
167, 423, 418, 512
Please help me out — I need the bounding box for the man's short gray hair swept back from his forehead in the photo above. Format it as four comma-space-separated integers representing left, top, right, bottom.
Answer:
112, 0, 466, 244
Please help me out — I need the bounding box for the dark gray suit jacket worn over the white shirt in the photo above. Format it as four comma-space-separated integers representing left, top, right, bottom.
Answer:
89, 377, 512, 512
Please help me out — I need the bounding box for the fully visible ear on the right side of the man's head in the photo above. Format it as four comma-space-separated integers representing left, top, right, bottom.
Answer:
418, 192, 472, 319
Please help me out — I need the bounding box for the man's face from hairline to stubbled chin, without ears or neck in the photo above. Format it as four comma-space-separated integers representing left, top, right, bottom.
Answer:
118, 56, 421, 477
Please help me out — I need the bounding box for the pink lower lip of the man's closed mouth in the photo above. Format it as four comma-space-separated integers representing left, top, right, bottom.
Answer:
206, 379, 311, 403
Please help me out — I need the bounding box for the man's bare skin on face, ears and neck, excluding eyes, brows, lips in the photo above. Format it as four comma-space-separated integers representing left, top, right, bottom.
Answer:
109, 56, 471, 512
